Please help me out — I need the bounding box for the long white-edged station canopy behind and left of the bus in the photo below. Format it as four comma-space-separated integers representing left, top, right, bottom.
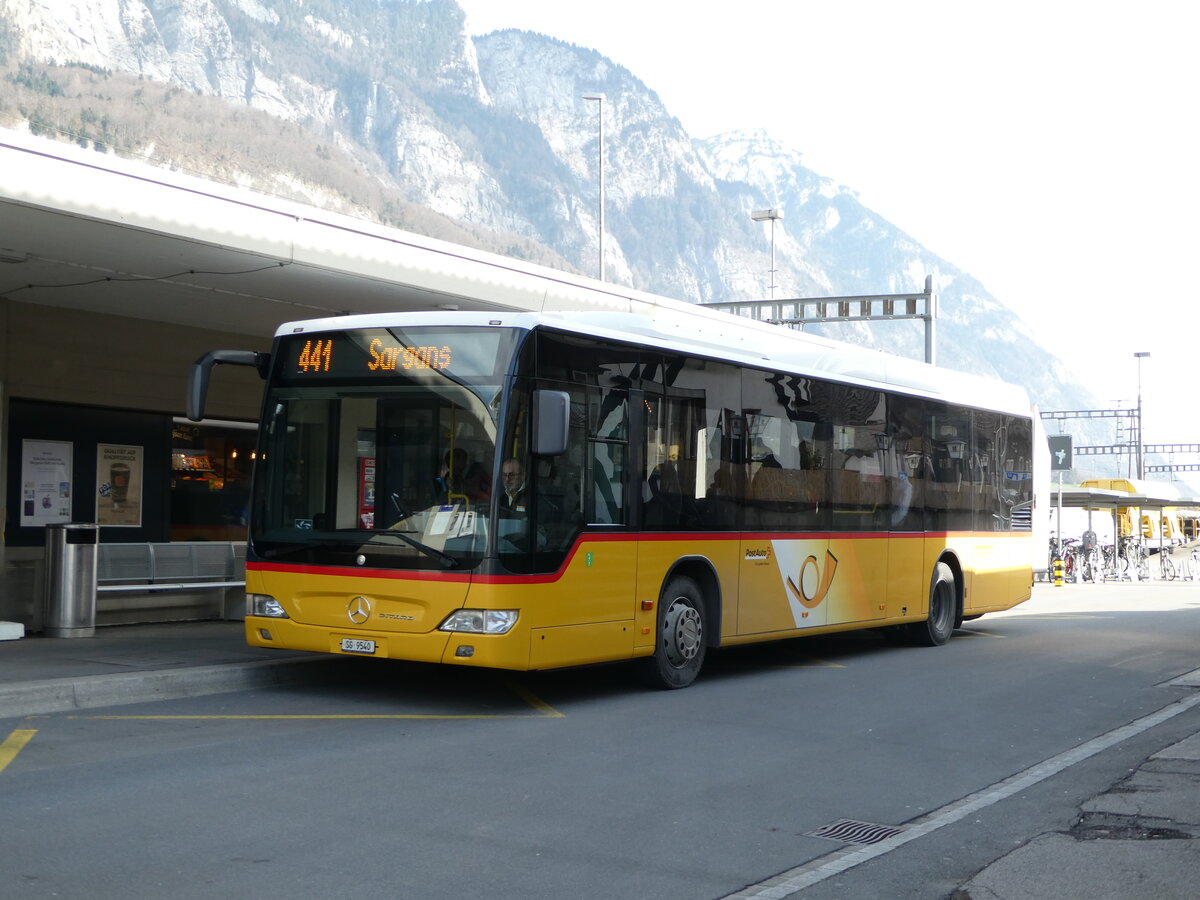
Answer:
0, 128, 637, 337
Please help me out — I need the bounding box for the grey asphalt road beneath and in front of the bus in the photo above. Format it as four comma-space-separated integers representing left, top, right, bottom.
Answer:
0, 583, 1200, 900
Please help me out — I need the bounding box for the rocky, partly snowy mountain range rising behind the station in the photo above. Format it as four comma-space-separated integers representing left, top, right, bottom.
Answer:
0, 0, 1111, 451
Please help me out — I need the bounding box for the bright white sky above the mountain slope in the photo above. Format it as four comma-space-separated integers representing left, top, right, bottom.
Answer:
458, 0, 1200, 462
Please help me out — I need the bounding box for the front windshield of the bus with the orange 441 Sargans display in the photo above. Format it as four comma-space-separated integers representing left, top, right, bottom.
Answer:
250, 326, 517, 569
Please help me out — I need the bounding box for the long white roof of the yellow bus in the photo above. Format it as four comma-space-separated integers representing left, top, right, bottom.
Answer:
276, 298, 1031, 415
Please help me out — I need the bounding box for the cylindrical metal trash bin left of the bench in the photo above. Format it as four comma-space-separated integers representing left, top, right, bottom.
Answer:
42, 522, 100, 637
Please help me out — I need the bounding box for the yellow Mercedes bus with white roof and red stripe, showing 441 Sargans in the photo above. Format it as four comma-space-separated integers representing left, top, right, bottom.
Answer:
188, 305, 1044, 688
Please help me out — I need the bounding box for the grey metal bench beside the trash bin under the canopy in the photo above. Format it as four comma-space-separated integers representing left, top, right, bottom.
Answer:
96, 541, 246, 593
